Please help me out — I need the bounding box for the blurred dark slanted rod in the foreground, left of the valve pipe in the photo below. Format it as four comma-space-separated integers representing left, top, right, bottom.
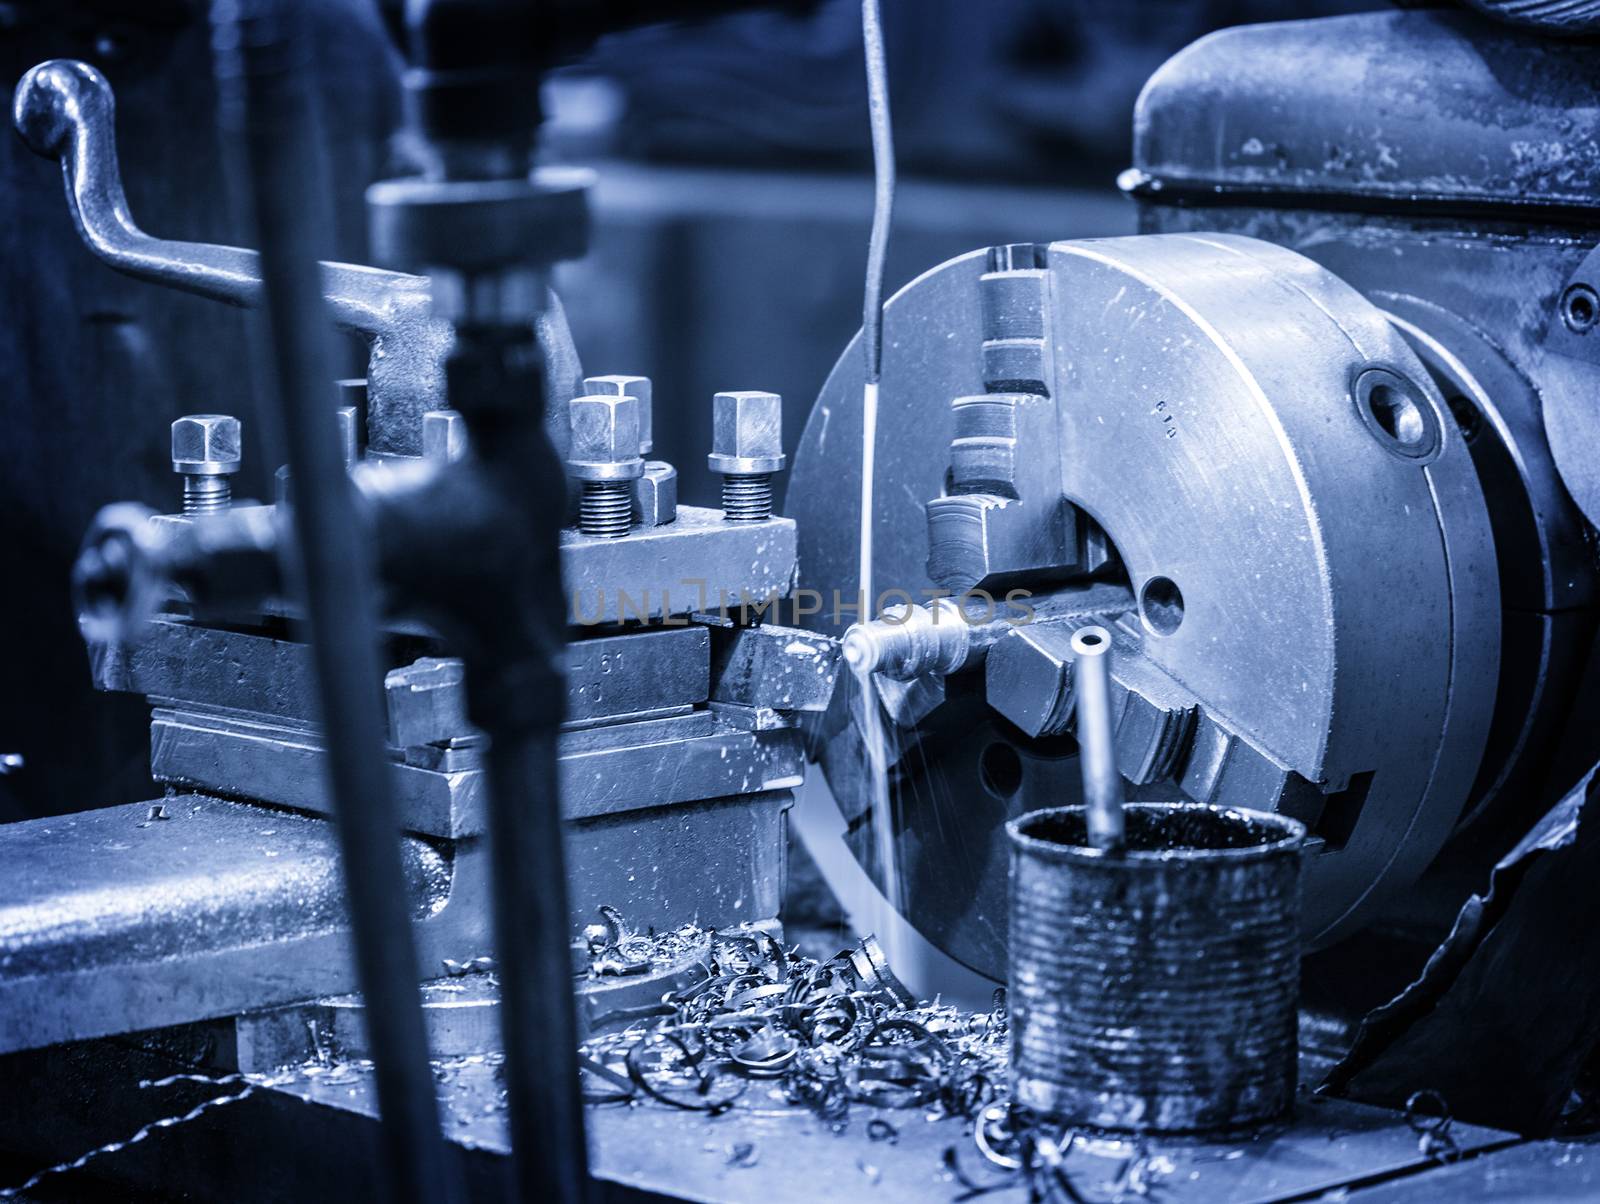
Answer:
211, 0, 454, 1204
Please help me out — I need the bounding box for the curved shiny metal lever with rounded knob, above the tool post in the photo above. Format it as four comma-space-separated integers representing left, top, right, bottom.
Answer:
11, 59, 429, 338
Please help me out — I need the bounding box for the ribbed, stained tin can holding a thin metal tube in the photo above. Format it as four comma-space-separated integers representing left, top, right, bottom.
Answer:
1008, 802, 1306, 1134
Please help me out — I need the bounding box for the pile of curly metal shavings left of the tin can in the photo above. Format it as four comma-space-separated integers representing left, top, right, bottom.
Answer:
579, 909, 1008, 1140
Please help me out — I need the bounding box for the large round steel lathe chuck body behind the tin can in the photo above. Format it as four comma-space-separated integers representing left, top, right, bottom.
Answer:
787, 234, 1501, 973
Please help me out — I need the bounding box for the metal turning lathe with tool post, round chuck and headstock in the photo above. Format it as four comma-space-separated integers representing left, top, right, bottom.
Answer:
0, 3, 1600, 1199
